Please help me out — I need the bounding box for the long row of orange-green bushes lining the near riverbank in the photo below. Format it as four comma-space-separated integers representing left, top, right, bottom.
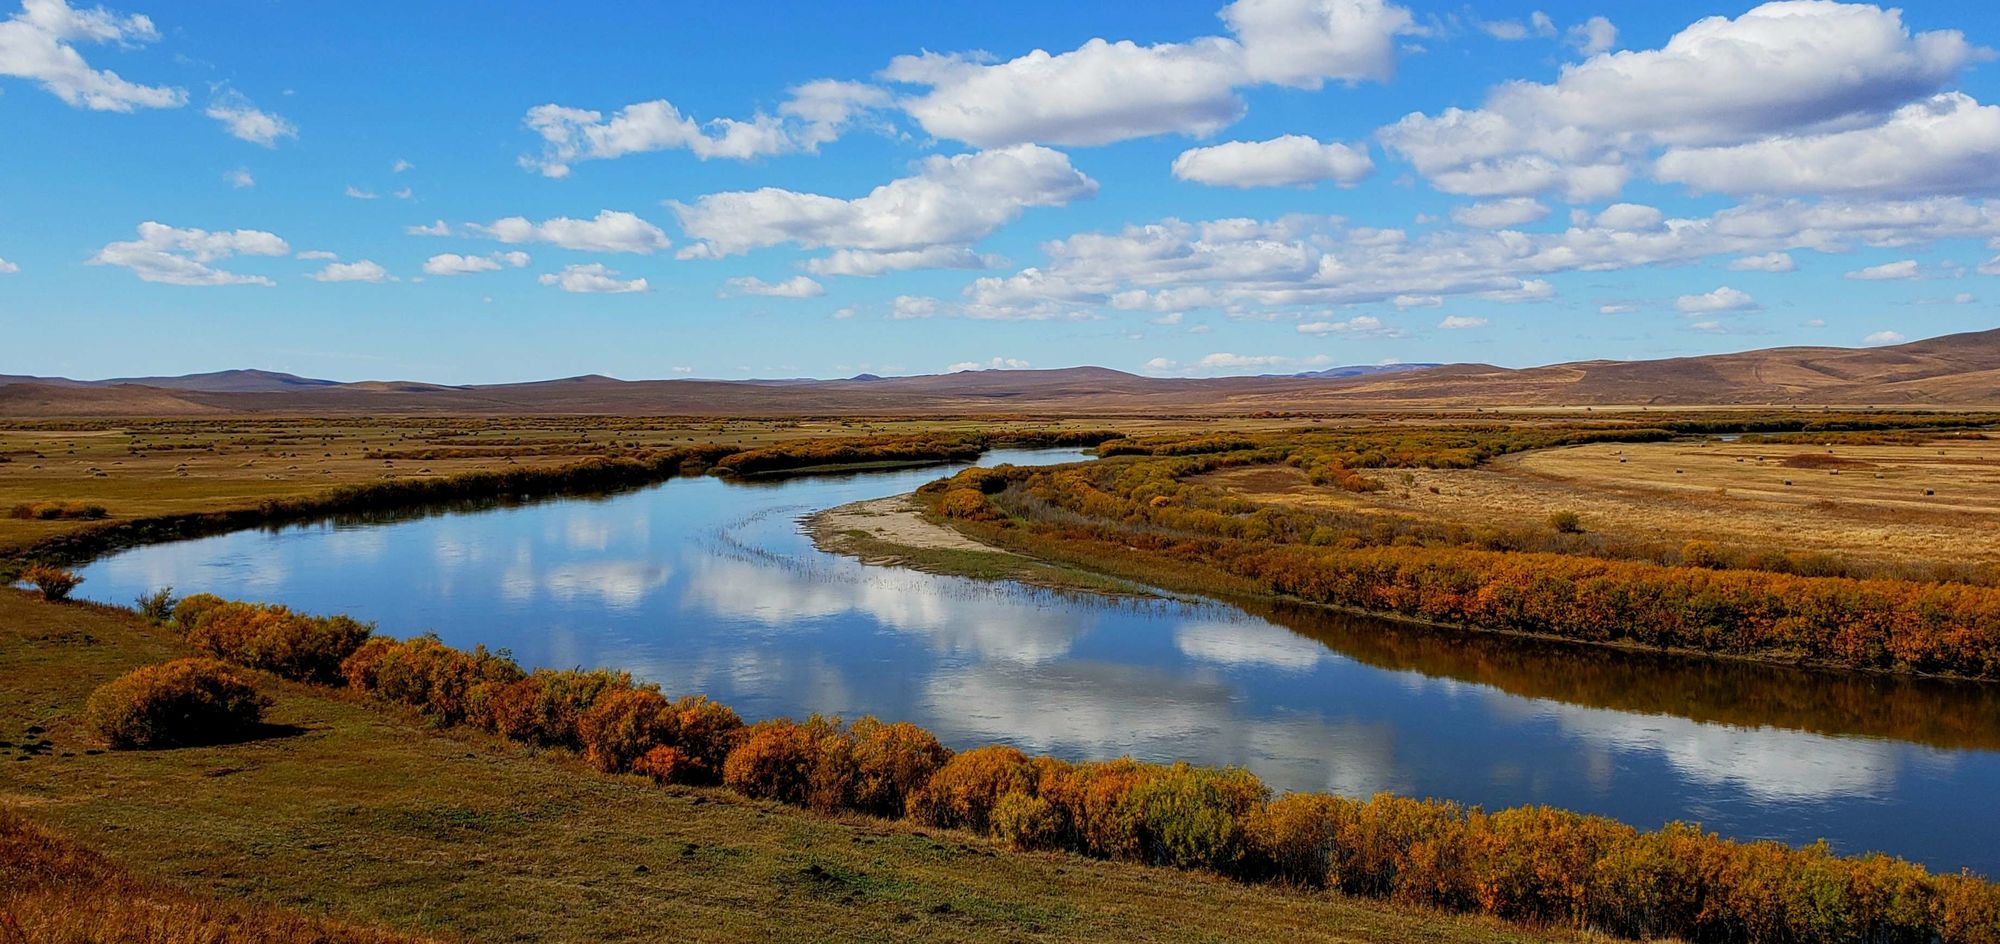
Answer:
168, 598, 2000, 944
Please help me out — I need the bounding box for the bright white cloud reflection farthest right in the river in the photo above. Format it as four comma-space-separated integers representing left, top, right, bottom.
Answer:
1544, 704, 1950, 800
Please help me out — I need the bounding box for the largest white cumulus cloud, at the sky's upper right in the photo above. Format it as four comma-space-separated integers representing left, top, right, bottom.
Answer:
1380, 0, 1988, 200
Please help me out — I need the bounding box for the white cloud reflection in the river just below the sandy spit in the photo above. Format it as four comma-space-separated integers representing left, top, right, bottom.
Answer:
684, 558, 1084, 664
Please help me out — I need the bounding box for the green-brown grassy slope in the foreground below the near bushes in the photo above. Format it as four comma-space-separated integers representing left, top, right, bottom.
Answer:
0, 590, 1576, 942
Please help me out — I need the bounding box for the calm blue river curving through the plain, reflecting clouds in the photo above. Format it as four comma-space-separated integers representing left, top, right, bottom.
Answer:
66, 450, 2000, 876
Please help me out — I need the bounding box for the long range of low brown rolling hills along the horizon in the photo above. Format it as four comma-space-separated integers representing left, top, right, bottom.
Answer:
0, 328, 2000, 418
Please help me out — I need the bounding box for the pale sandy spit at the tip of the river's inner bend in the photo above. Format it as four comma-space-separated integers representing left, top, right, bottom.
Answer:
800, 494, 1158, 596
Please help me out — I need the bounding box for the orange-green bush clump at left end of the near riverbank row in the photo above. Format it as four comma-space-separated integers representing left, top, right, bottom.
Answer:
174, 594, 374, 682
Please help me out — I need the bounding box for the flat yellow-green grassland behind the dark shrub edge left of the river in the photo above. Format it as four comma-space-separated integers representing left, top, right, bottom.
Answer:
0, 416, 1344, 558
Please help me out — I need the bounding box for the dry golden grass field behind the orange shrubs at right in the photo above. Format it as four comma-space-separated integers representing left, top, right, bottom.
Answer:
1202, 440, 2000, 564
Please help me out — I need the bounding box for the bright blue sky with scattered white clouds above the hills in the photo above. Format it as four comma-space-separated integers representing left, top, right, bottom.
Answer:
0, 0, 2000, 382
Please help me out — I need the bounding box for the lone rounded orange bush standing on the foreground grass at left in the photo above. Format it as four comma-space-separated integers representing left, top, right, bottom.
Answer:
84, 658, 270, 748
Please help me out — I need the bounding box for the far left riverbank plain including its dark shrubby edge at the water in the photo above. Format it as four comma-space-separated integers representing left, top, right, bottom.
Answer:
0, 418, 1118, 578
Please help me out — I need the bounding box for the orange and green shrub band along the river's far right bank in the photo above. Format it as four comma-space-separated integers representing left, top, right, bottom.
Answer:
918, 420, 2000, 680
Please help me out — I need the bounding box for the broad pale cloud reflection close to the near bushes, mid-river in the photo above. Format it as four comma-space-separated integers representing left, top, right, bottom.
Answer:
924, 662, 1398, 796
